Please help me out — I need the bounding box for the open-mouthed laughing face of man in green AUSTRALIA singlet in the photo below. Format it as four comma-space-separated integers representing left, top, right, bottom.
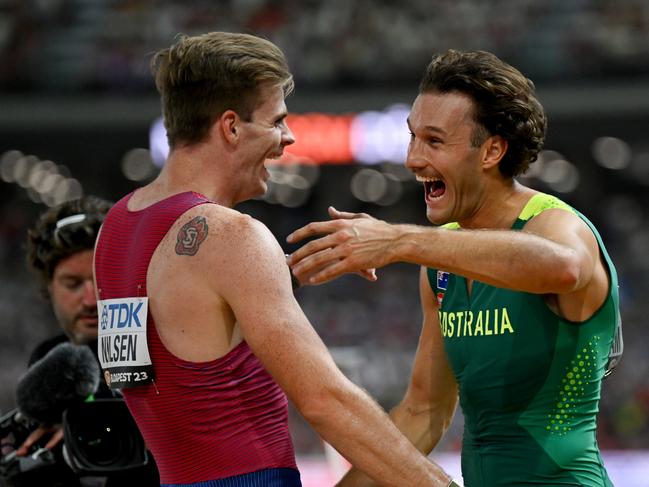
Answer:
406, 92, 492, 225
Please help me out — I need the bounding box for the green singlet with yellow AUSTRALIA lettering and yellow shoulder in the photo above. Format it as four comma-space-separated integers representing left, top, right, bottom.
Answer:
428, 194, 619, 487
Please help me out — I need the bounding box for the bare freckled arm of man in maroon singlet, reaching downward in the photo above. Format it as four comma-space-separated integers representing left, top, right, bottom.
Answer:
211, 216, 449, 487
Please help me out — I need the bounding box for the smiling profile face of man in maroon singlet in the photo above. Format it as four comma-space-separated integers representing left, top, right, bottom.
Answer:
236, 85, 295, 202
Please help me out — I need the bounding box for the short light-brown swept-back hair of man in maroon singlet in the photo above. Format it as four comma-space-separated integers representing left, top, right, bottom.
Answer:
151, 32, 293, 149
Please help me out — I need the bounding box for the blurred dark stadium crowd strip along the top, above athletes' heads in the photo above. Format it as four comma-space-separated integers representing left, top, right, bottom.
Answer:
0, 0, 649, 90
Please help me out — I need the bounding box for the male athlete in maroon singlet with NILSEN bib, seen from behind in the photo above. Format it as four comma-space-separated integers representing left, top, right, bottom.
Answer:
95, 32, 450, 487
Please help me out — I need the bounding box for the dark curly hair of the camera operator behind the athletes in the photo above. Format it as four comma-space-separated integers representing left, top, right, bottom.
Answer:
27, 196, 113, 297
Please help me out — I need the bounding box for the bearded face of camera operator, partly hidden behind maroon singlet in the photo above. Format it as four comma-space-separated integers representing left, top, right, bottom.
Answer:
48, 250, 97, 345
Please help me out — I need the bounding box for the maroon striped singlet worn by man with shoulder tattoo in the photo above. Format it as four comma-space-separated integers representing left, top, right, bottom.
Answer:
95, 192, 301, 487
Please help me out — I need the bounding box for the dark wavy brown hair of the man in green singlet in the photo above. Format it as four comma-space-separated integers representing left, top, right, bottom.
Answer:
419, 49, 547, 177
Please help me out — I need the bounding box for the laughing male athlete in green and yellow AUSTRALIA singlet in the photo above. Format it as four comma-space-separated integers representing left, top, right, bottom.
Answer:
289, 51, 619, 487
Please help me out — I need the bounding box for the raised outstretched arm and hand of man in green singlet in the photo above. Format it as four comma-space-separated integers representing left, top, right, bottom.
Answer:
289, 210, 603, 304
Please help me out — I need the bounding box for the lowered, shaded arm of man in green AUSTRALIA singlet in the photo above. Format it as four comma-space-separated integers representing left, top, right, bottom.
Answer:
340, 268, 457, 487
